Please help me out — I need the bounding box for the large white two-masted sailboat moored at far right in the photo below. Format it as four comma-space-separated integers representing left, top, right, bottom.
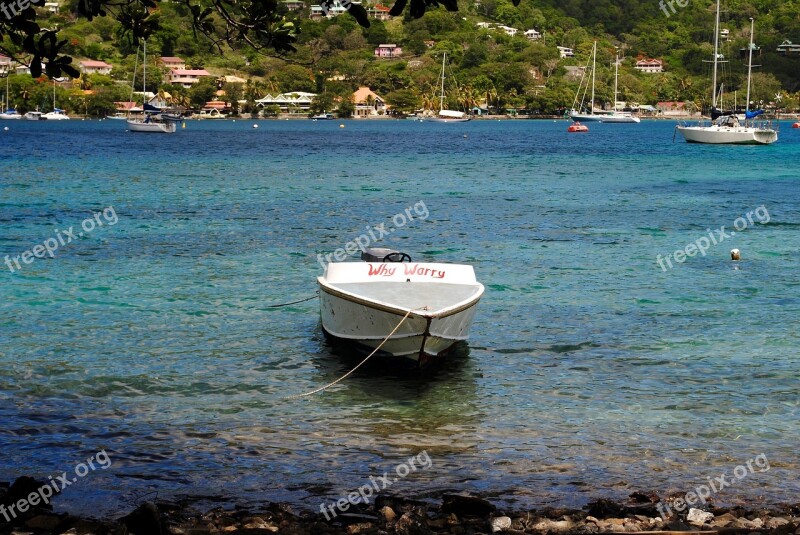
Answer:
675, 0, 778, 145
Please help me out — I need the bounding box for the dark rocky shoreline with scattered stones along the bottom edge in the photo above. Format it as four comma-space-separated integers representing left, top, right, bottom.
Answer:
0, 477, 800, 535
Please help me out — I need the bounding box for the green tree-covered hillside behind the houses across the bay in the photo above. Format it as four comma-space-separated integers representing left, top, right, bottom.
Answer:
0, 0, 800, 116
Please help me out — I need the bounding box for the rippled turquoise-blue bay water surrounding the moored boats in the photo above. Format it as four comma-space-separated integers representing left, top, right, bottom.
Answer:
0, 120, 800, 515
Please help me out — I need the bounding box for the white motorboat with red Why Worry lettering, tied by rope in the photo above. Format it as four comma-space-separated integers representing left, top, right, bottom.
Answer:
317, 248, 484, 366
